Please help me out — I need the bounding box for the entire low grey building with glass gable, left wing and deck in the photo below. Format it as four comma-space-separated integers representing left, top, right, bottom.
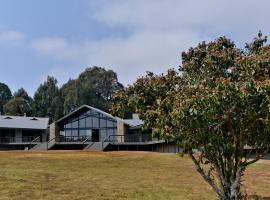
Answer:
0, 105, 179, 153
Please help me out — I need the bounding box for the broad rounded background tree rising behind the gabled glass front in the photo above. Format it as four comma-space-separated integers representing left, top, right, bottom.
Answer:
61, 67, 123, 114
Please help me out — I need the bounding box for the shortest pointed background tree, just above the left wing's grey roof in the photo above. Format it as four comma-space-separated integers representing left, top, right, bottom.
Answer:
4, 88, 33, 116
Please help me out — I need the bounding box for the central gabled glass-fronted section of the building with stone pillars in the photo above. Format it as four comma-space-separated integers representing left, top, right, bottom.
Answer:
50, 105, 146, 142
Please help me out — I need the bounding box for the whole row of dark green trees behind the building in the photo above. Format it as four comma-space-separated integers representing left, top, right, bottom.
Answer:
0, 66, 123, 122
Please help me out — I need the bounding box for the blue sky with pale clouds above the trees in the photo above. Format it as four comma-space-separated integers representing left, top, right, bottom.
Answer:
0, 0, 270, 95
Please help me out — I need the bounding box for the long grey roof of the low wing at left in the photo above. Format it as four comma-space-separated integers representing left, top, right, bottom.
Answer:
0, 115, 49, 130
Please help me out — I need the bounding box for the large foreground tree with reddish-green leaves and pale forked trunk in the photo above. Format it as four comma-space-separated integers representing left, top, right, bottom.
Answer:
112, 33, 270, 200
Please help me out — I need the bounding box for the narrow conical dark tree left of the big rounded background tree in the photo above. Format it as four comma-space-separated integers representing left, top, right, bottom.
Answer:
32, 76, 63, 121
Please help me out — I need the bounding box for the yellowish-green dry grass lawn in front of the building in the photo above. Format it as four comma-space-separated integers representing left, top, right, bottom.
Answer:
0, 151, 270, 200
